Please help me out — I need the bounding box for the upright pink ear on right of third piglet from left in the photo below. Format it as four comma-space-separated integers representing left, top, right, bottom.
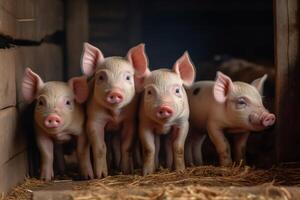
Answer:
173, 51, 196, 86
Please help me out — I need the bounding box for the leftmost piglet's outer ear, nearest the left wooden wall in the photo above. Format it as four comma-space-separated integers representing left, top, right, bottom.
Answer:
22, 68, 44, 103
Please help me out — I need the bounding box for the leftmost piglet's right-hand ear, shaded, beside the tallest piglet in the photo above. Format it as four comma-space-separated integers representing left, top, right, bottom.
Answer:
69, 76, 89, 103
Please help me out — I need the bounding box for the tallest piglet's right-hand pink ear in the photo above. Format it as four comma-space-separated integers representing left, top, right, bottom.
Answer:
127, 44, 150, 77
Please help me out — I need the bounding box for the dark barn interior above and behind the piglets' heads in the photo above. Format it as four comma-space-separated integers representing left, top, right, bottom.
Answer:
89, 0, 274, 79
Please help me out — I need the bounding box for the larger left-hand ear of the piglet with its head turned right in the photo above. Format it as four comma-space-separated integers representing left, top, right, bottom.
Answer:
213, 72, 234, 103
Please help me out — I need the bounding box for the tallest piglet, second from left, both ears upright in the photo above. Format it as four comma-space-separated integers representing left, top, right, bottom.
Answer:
82, 43, 148, 178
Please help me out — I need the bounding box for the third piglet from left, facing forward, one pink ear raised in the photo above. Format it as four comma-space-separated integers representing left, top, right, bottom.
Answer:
139, 53, 195, 175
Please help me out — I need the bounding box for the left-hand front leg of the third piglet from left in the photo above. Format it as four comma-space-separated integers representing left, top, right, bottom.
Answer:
139, 126, 155, 176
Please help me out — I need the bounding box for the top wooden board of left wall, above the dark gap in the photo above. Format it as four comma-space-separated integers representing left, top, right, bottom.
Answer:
0, 0, 64, 41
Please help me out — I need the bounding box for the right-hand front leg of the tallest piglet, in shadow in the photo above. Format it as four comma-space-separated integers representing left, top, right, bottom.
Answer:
121, 122, 135, 174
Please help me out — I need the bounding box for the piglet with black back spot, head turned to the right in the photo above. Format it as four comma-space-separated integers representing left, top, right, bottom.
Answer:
186, 72, 275, 166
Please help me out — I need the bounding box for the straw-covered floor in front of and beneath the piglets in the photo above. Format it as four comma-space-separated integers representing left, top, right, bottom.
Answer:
4, 165, 300, 200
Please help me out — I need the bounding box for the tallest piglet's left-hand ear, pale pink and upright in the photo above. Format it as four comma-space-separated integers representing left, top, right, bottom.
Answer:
81, 42, 104, 76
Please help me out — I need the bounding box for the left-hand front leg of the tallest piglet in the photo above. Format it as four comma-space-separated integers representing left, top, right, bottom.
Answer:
87, 121, 107, 178
